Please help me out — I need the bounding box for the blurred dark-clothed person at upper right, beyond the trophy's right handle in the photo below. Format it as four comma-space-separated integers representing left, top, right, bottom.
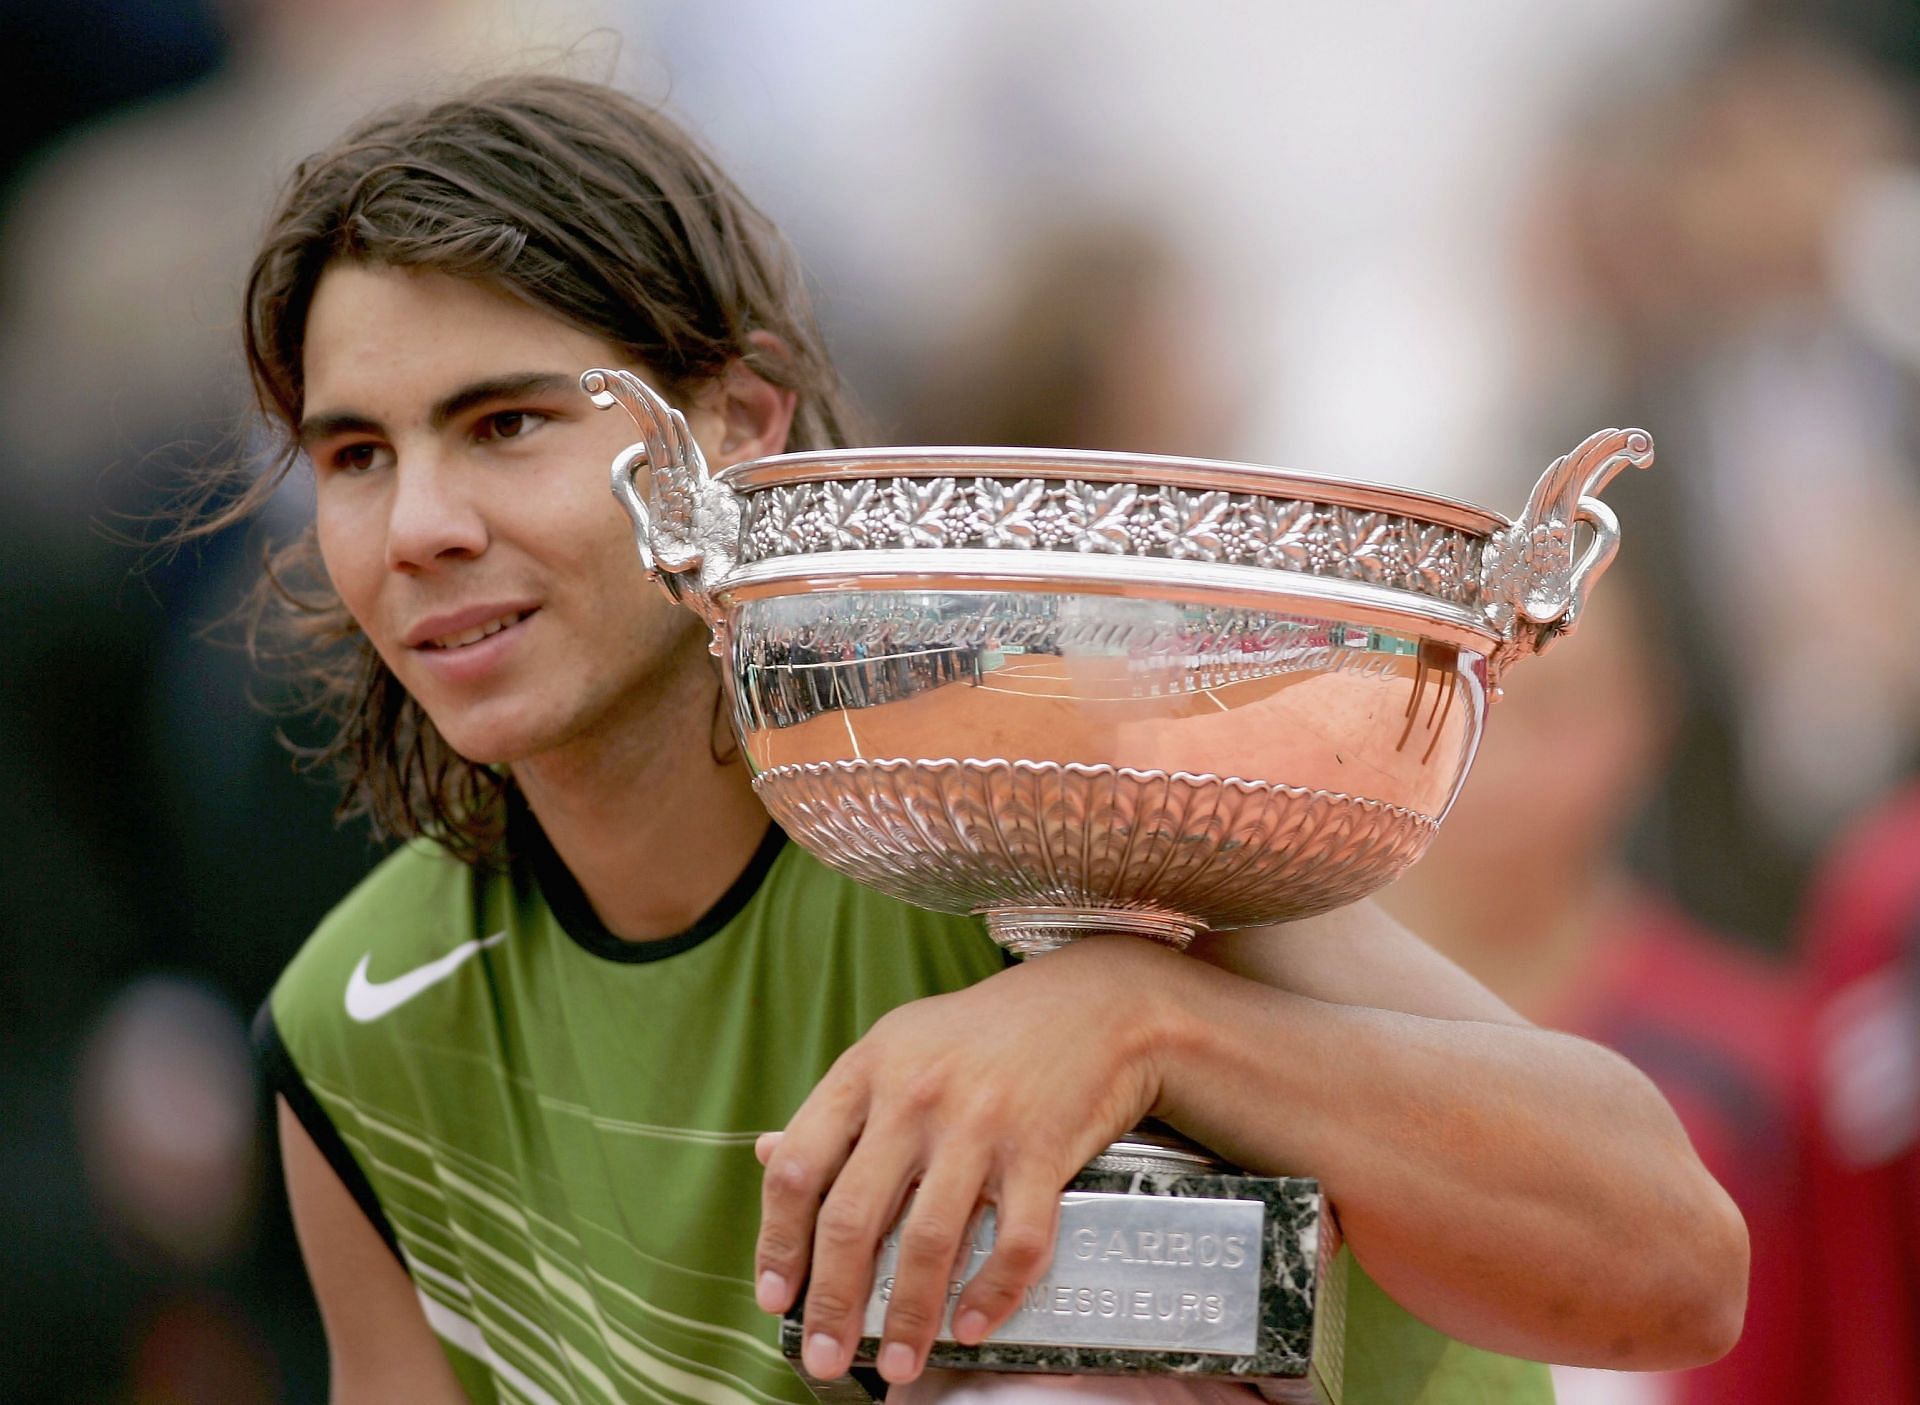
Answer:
1532, 36, 1920, 946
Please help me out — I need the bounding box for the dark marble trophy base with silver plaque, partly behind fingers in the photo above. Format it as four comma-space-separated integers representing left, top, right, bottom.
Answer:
780, 1134, 1346, 1405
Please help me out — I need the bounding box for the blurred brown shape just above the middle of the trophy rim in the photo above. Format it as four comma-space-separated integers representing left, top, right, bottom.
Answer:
899, 219, 1238, 457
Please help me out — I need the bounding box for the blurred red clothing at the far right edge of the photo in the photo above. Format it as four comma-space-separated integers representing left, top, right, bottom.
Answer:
1805, 787, 1920, 1405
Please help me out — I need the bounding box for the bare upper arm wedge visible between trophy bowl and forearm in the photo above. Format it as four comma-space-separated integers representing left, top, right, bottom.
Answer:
1188, 900, 1526, 1025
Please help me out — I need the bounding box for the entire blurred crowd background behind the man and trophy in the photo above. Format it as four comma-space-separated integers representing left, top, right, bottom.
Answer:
0, 0, 1920, 1405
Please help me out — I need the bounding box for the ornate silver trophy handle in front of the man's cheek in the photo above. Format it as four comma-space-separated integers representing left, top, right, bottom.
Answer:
580, 367, 739, 620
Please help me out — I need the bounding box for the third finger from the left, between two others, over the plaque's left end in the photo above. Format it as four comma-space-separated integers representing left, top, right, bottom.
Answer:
876, 1148, 987, 1386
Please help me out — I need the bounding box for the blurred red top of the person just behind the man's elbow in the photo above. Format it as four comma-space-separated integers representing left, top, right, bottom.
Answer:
1544, 896, 1826, 1405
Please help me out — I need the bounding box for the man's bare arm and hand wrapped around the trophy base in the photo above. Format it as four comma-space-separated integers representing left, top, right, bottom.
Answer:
758, 904, 1747, 1380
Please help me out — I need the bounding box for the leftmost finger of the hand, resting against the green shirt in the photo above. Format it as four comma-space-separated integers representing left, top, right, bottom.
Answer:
753, 1067, 866, 1313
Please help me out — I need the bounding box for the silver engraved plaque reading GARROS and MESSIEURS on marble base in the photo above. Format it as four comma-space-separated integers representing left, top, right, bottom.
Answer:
864, 1192, 1265, 1355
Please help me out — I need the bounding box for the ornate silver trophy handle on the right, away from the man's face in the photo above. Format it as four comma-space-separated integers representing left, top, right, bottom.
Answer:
1480, 430, 1653, 679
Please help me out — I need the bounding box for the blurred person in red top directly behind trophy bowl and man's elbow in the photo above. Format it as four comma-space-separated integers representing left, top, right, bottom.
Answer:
1384, 571, 1826, 1405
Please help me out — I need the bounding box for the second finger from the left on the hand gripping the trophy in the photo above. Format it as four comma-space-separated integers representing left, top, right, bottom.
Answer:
801, 1125, 920, 1380
